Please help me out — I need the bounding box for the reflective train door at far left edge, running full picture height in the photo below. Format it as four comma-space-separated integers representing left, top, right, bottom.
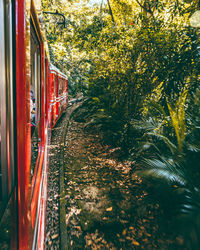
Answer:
0, 0, 17, 249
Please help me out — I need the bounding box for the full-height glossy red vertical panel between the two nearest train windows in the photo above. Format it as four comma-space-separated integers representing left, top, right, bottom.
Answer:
15, 0, 31, 249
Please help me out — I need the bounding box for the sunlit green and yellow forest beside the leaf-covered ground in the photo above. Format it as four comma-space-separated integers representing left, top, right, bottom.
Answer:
43, 0, 200, 249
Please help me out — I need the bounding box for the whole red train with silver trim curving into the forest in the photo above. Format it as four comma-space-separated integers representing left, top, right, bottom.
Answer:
0, 0, 68, 249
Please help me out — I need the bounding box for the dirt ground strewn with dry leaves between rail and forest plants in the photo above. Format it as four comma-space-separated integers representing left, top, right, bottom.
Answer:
63, 120, 181, 249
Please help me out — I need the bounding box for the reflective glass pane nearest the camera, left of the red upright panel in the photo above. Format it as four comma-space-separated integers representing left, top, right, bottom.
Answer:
0, 0, 14, 206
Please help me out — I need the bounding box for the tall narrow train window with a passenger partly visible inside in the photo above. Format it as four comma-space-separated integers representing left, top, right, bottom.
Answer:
30, 21, 41, 176
